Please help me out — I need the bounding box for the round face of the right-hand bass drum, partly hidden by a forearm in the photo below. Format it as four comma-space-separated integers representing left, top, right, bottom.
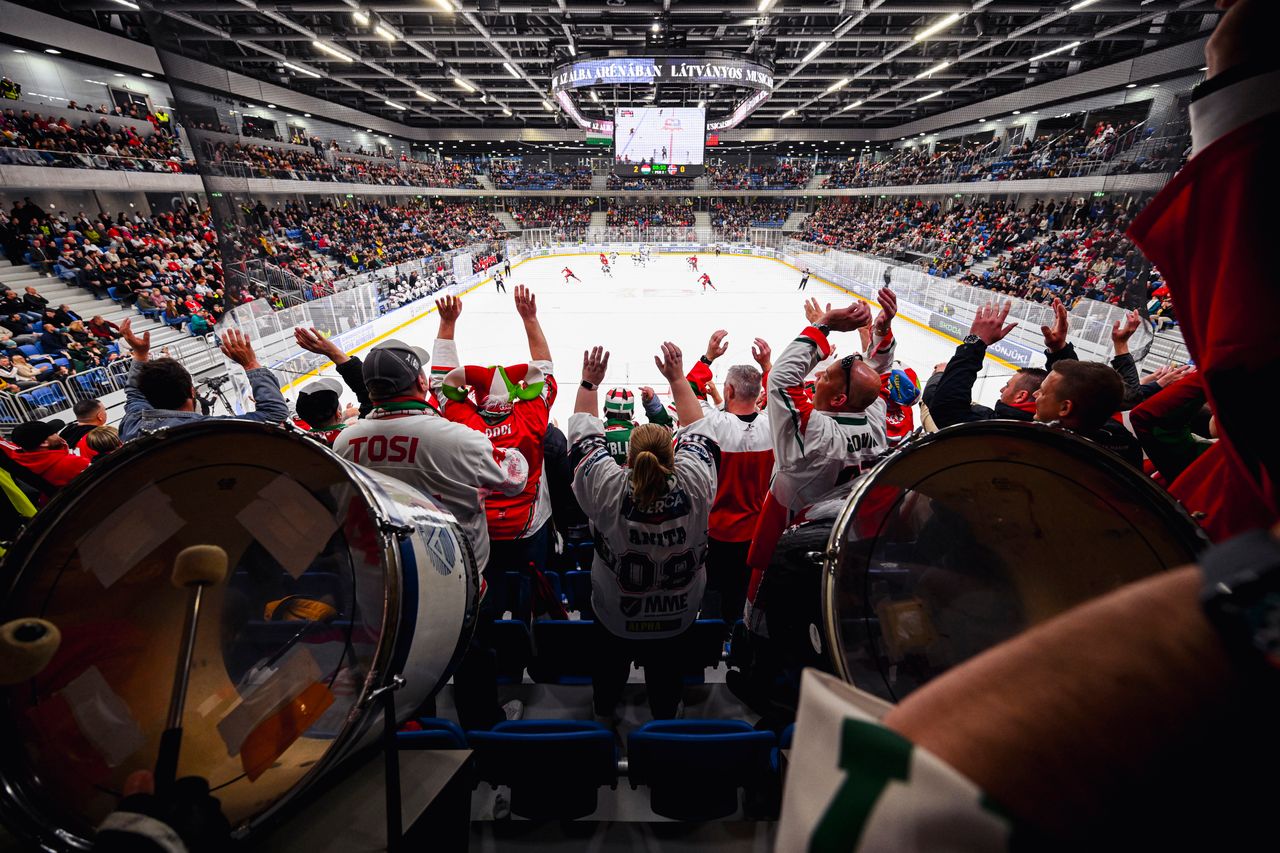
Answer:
823, 421, 1207, 702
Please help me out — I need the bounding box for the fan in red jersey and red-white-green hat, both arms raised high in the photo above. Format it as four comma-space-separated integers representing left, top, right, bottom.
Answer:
431, 284, 557, 619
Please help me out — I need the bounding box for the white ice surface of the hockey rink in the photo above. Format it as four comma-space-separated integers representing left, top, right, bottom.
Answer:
317, 252, 1011, 425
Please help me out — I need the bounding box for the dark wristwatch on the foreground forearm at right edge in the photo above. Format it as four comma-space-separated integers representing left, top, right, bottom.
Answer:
1199, 530, 1280, 690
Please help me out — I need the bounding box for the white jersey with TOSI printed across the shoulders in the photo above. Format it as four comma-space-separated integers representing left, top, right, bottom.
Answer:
333, 403, 529, 569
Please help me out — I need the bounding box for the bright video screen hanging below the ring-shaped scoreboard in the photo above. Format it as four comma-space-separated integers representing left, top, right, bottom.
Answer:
613, 106, 707, 178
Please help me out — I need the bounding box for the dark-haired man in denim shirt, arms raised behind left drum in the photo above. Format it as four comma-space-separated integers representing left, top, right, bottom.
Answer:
120, 320, 289, 442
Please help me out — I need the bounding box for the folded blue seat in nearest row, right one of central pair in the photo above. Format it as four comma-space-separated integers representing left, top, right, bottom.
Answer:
627, 720, 777, 821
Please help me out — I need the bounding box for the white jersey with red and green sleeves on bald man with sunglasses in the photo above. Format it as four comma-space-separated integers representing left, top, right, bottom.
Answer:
768, 325, 897, 512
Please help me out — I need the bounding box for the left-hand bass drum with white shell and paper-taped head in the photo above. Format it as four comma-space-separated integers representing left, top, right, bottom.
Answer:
0, 420, 479, 849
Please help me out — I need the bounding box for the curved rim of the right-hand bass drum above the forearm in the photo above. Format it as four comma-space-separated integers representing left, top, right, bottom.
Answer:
820, 419, 1210, 684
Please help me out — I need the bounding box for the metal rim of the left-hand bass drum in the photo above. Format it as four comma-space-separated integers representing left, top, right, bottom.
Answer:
0, 418, 403, 850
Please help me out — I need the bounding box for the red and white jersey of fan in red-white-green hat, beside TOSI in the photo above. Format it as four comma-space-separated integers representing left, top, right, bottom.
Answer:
431, 339, 557, 540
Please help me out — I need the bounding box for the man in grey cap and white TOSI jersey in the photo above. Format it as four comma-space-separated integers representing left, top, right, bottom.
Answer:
333, 339, 529, 729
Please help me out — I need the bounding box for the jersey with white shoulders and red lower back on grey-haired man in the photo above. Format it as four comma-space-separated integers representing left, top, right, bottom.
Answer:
699, 401, 773, 542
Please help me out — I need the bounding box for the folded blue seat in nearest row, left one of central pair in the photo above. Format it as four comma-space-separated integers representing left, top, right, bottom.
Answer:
467, 720, 618, 820
